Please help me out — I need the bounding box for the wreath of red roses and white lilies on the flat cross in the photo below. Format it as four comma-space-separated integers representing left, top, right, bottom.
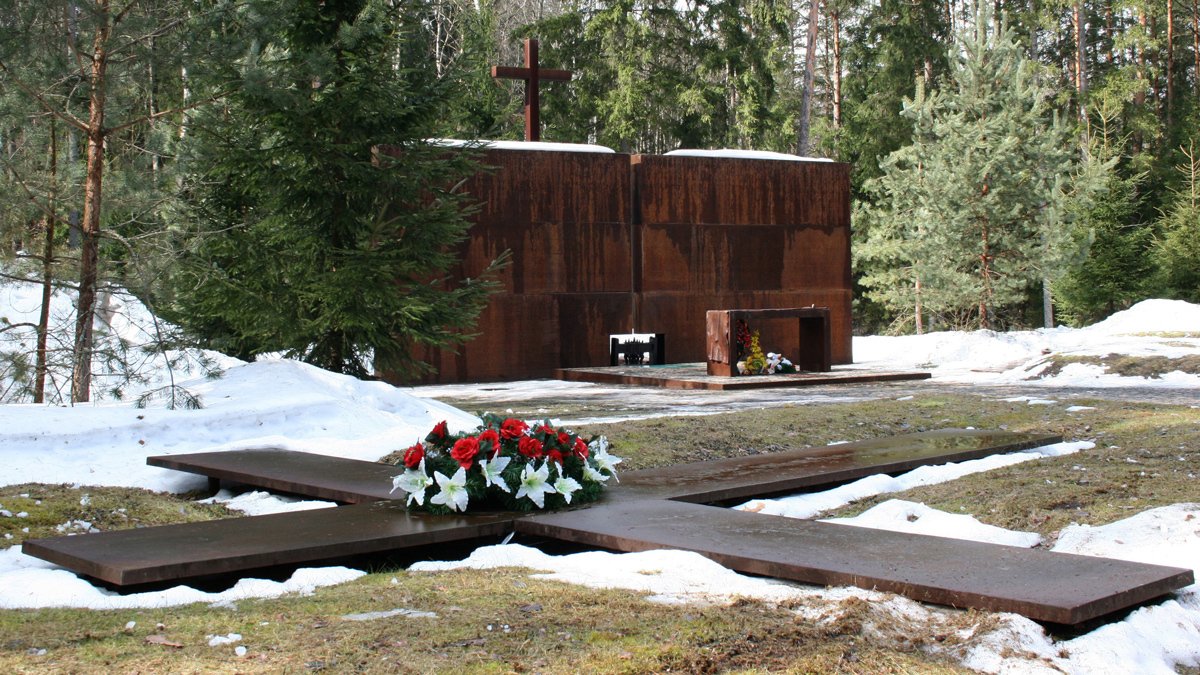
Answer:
392, 414, 620, 514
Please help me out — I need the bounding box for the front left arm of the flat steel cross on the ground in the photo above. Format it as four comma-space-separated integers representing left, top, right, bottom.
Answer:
23, 502, 514, 586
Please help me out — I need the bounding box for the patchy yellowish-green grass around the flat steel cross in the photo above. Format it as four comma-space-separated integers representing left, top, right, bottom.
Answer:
0, 395, 1200, 673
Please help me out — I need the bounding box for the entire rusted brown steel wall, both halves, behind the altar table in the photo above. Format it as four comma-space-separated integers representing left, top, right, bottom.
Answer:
403, 150, 852, 382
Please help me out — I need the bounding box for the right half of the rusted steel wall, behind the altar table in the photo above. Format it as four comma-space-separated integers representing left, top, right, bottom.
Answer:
634, 155, 852, 364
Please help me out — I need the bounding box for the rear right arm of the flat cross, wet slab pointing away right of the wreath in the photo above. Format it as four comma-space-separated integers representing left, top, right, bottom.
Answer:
612, 429, 1062, 503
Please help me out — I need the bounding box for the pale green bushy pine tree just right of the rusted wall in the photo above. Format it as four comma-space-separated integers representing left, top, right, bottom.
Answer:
860, 5, 1108, 328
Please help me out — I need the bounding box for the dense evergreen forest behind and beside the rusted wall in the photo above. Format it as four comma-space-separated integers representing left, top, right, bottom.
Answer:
0, 0, 1200, 402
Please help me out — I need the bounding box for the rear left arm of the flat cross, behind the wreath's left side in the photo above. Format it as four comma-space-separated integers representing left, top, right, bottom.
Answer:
146, 448, 404, 503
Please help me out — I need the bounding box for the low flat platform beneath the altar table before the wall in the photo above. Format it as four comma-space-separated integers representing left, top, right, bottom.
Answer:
554, 363, 930, 392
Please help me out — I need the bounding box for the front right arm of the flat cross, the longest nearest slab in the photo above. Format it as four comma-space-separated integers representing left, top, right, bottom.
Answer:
515, 500, 1194, 625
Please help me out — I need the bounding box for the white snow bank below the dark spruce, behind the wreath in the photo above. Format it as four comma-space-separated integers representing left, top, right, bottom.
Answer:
0, 360, 479, 492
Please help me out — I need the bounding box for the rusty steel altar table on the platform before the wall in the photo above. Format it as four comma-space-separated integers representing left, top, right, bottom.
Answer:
704, 307, 833, 377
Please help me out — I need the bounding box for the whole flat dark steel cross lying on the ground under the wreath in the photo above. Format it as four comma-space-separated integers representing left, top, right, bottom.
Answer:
23, 429, 1194, 623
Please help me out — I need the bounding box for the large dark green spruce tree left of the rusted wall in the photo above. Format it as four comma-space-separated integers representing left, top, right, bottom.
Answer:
172, 0, 504, 376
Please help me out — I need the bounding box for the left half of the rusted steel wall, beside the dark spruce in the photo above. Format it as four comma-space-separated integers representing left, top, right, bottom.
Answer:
415, 150, 634, 382
